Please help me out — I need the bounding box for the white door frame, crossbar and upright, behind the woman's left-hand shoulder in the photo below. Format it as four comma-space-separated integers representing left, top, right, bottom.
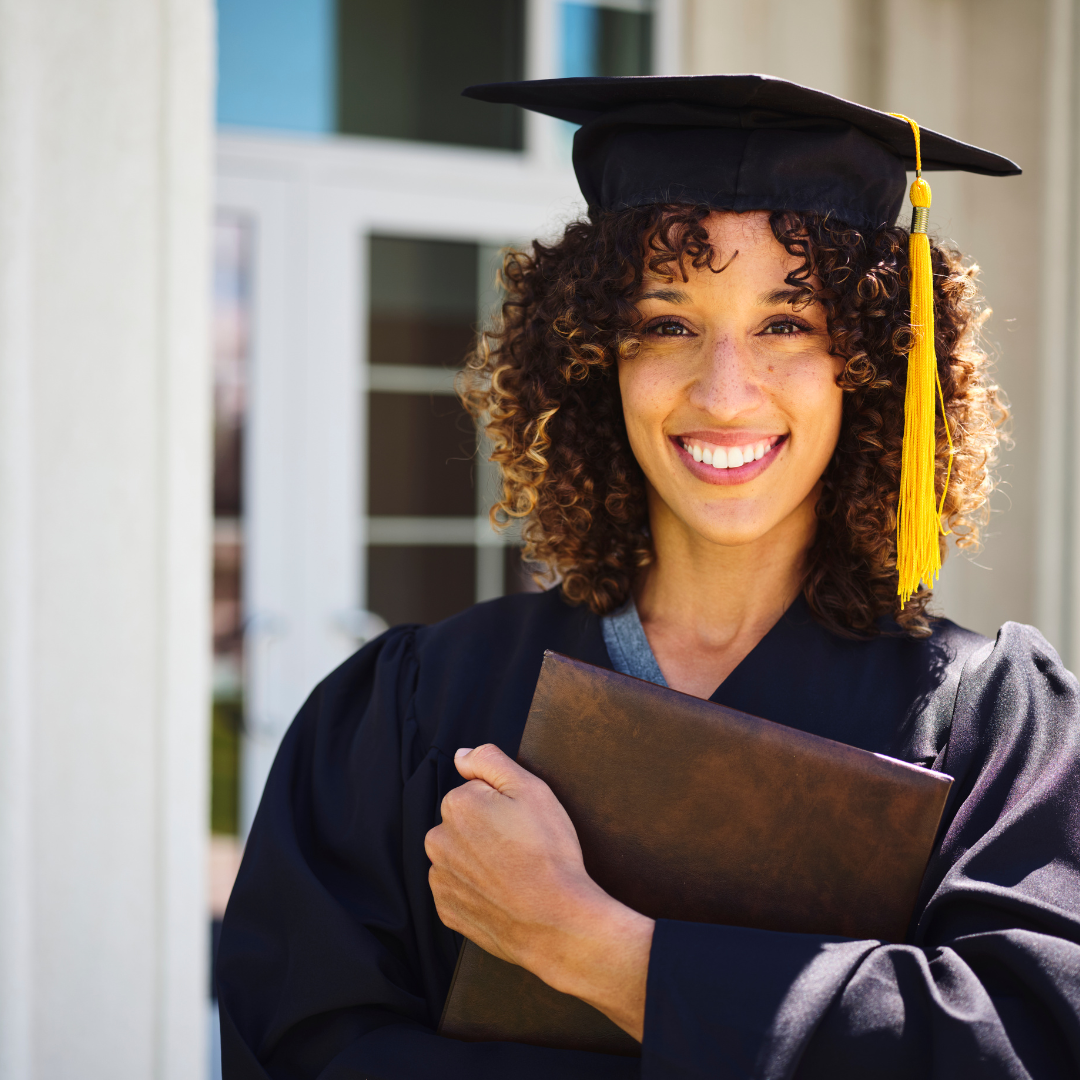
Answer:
217, 134, 582, 834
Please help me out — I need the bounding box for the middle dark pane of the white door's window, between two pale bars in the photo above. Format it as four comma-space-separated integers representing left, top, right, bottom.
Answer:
367, 392, 476, 517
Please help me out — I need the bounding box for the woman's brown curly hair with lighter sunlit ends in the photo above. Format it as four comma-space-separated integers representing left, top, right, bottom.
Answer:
459, 205, 1007, 636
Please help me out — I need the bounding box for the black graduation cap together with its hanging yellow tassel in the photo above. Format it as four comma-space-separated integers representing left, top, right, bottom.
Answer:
464, 75, 1021, 604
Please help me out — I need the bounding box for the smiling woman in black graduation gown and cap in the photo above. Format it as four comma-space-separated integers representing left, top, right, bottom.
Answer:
218, 77, 1080, 1080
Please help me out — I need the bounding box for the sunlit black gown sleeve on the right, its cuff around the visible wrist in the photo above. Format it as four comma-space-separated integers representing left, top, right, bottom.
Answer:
642, 623, 1080, 1080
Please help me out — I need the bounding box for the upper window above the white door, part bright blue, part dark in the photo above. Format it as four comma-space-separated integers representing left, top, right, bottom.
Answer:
217, 0, 525, 150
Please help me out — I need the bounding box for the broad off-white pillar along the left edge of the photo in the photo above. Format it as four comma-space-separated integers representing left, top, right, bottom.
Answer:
0, 0, 213, 1080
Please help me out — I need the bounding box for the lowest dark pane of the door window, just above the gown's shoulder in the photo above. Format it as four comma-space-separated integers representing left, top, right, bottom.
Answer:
367, 545, 476, 626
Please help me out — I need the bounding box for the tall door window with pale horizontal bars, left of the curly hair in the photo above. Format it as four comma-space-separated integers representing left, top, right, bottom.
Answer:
365, 235, 516, 624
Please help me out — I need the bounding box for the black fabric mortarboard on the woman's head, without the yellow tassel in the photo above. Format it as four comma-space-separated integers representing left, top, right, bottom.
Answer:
464, 75, 1020, 230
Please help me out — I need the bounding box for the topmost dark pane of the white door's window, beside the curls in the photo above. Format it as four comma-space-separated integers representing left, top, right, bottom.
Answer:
368, 237, 480, 367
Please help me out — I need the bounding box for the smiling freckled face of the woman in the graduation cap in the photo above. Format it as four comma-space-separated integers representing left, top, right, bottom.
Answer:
619, 213, 843, 545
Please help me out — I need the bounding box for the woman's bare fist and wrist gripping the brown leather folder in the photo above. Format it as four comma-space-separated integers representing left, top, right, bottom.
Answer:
424, 744, 653, 1039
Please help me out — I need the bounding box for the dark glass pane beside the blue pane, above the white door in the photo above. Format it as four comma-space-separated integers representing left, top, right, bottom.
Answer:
337, 0, 525, 150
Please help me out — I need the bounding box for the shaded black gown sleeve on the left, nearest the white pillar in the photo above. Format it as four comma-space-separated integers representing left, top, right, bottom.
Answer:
217, 627, 639, 1080
